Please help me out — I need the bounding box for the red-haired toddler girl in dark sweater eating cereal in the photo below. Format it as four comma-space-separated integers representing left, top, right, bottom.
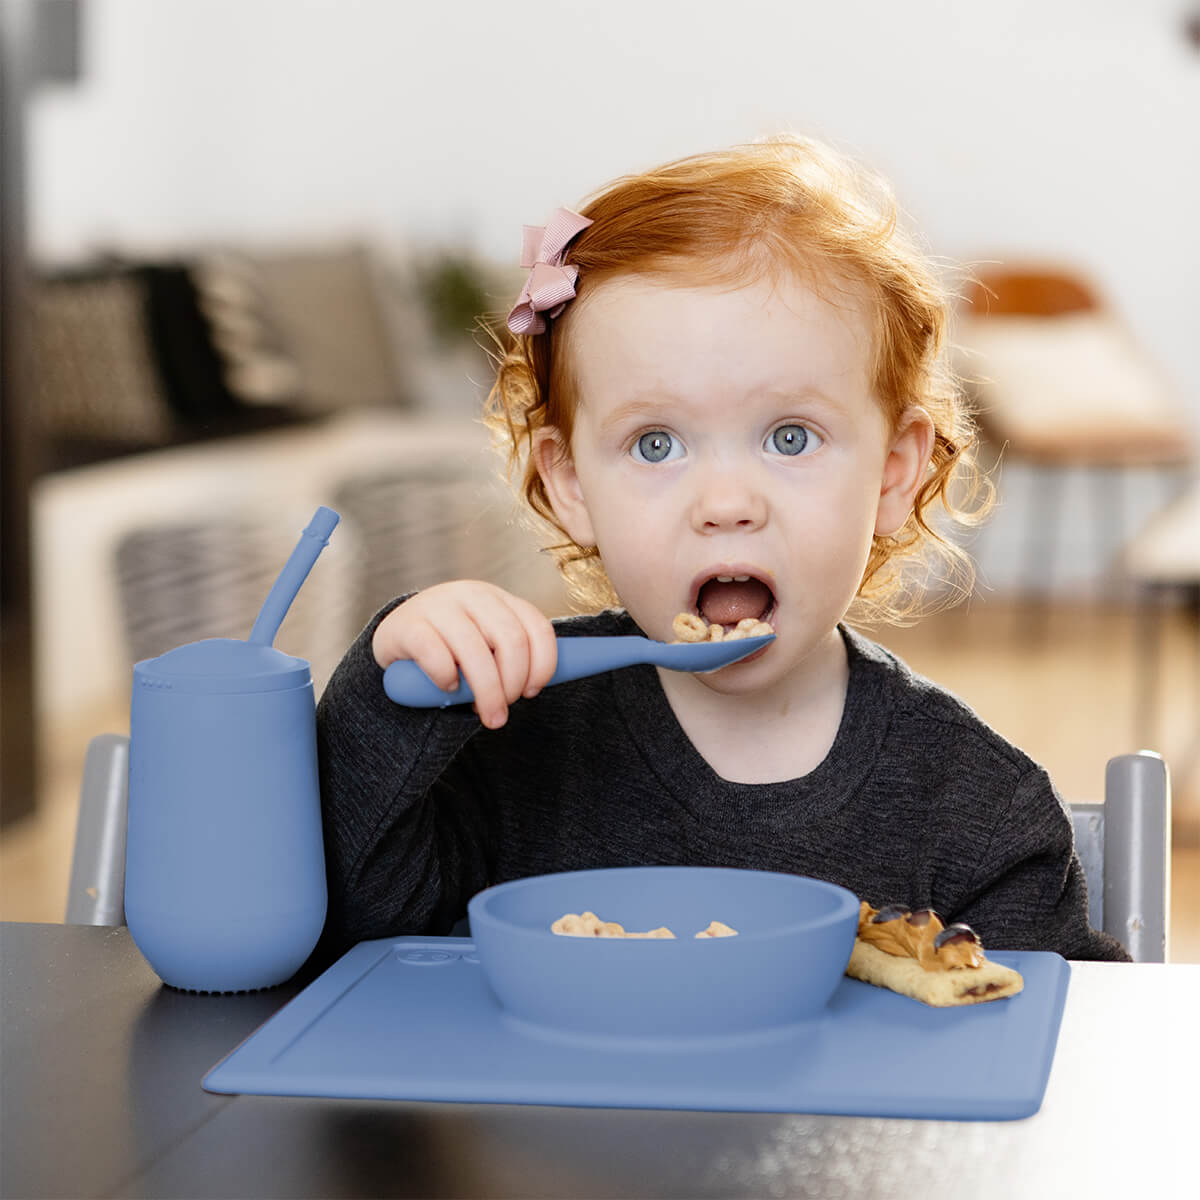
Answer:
318, 137, 1127, 959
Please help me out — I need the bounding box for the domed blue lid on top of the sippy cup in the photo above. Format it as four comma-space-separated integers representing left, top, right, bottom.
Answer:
133, 637, 312, 692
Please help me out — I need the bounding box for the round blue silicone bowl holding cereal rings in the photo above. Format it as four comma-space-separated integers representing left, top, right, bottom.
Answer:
468, 866, 858, 1038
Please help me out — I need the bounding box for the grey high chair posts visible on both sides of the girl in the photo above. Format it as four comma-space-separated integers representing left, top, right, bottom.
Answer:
66, 733, 1171, 962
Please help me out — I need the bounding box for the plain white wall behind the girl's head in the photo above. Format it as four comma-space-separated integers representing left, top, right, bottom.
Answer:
30, 0, 1200, 431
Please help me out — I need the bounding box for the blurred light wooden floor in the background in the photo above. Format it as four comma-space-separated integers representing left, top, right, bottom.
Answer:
0, 600, 1200, 962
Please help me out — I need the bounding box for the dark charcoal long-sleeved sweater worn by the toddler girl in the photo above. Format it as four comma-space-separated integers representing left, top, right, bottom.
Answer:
314, 605, 1128, 961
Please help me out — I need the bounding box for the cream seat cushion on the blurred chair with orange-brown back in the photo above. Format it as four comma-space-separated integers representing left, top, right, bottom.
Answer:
955, 313, 1192, 463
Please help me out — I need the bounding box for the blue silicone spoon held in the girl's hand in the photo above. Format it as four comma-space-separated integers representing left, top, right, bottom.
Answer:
383, 634, 775, 708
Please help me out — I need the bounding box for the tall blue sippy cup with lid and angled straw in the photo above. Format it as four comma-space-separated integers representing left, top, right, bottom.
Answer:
125, 508, 338, 991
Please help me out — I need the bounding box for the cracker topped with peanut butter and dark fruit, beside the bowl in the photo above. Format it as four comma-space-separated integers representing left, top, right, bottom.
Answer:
846, 900, 1025, 1008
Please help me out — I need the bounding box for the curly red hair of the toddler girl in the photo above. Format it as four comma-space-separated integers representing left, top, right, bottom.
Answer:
485, 136, 991, 622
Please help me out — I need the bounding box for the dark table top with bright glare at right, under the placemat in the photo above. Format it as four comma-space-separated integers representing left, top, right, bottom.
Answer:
0, 924, 1200, 1200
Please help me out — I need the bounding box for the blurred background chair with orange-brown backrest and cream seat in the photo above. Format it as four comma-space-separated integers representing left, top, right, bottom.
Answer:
956, 265, 1195, 614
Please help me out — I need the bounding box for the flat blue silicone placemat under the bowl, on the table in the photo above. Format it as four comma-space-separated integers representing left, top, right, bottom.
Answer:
204, 937, 1070, 1120
